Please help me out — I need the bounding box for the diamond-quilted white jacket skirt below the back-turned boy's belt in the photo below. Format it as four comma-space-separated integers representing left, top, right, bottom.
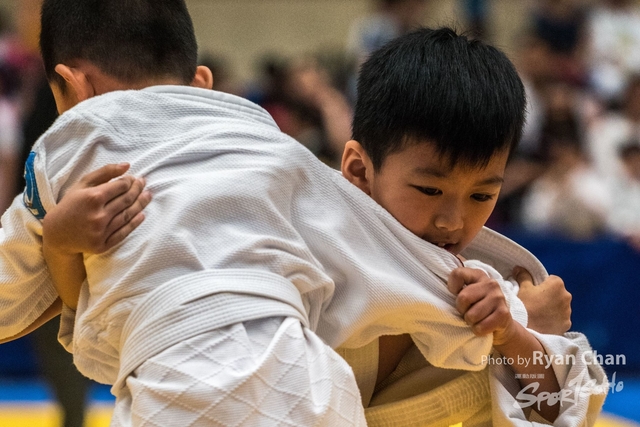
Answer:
111, 318, 366, 427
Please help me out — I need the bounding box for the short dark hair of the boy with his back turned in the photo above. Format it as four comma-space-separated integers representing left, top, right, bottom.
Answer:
40, 0, 198, 88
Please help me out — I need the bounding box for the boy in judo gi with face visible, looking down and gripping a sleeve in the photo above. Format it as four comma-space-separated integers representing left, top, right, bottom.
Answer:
340, 29, 606, 425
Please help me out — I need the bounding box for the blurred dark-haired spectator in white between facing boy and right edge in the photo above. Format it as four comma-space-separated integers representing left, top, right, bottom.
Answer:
522, 83, 610, 240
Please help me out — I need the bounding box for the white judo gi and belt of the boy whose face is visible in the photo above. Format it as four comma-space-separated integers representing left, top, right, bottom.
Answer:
337, 229, 608, 427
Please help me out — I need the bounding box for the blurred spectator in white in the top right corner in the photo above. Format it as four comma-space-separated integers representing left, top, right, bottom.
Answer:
587, 0, 640, 105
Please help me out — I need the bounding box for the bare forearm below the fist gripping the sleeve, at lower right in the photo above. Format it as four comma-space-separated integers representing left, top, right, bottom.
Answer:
494, 322, 560, 422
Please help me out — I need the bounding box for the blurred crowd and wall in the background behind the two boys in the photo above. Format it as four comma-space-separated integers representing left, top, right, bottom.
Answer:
0, 0, 640, 426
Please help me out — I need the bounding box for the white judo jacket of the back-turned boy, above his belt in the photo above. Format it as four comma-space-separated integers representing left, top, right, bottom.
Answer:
0, 86, 606, 424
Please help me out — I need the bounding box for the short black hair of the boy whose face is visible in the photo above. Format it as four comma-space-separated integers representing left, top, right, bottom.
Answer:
353, 28, 526, 171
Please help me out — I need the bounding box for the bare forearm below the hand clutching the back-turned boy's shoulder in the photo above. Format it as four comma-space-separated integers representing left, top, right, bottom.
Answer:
43, 244, 87, 310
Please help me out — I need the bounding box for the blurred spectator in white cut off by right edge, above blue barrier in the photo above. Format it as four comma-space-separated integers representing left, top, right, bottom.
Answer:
609, 140, 640, 251
